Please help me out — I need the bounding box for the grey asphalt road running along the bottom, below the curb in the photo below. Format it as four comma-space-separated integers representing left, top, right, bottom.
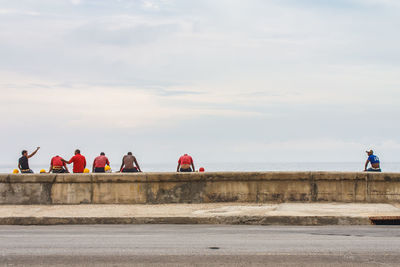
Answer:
0, 225, 400, 266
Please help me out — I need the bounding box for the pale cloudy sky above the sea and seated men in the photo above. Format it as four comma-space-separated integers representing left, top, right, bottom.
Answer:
0, 0, 400, 168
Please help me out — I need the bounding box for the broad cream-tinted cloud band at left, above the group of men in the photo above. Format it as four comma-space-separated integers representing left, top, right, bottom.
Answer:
0, 73, 262, 132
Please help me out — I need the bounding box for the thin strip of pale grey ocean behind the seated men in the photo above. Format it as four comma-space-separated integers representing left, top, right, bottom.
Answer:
0, 162, 400, 173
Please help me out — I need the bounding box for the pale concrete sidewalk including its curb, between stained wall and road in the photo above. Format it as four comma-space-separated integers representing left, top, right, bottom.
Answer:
0, 203, 400, 225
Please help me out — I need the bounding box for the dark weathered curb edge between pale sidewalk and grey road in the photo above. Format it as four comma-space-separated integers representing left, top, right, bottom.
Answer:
0, 216, 371, 226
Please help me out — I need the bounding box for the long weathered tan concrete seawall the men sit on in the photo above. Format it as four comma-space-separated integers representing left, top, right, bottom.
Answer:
0, 172, 400, 204
